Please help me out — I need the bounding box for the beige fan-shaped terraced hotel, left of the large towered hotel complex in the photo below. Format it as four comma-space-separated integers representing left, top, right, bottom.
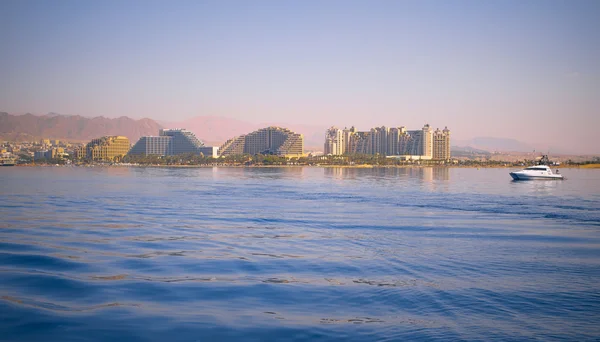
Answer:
219, 126, 304, 157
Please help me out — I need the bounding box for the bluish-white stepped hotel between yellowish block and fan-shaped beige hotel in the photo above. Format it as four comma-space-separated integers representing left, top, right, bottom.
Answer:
129, 128, 217, 158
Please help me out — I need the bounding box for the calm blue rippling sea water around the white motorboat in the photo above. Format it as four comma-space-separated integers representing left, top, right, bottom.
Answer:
0, 167, 600, 341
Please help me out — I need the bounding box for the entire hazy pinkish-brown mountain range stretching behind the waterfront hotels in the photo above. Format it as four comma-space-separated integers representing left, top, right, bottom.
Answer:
0, 112, 580, 153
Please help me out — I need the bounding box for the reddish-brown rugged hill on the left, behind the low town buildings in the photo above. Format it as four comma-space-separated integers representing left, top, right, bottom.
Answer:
0, 112, 162, 143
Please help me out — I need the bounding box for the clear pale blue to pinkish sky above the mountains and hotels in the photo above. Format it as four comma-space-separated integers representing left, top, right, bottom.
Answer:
0, 0, 600, 153
